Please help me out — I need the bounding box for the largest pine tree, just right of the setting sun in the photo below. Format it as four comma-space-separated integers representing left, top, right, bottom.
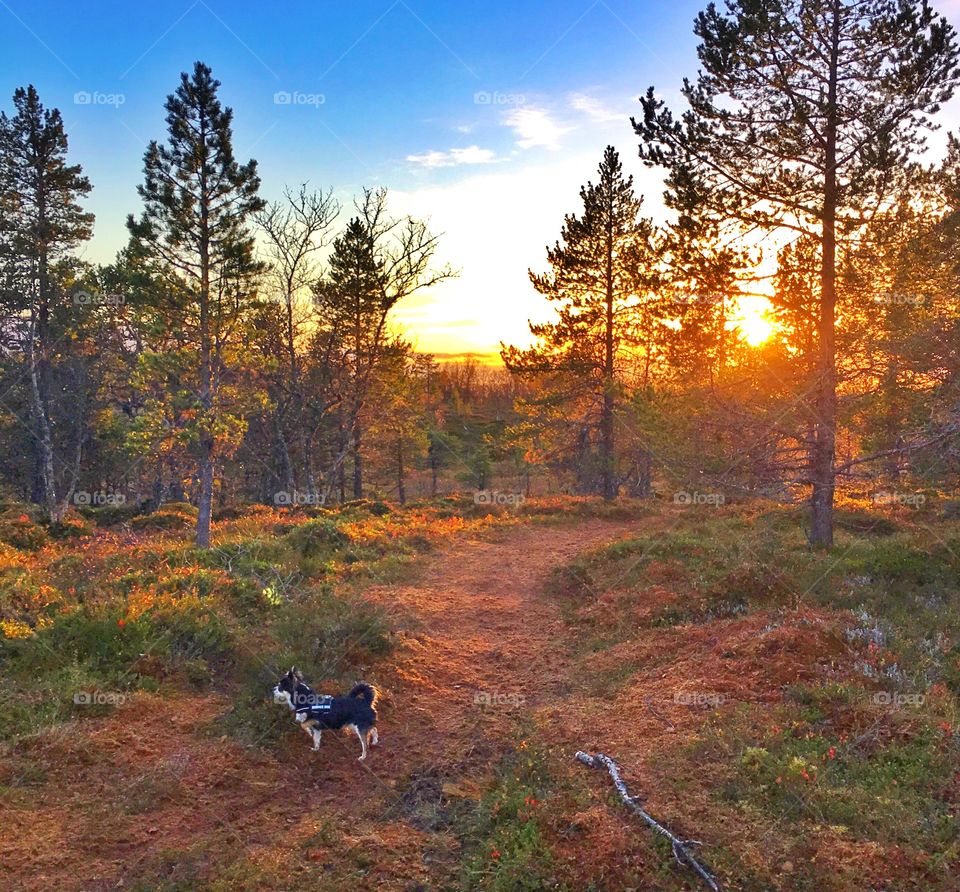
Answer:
634, 0, 957, 546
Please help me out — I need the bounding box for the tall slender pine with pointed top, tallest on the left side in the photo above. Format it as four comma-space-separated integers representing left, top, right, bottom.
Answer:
128, 62, 264, 548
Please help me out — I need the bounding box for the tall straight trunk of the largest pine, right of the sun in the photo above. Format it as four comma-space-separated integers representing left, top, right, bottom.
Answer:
810, 0, 841, 548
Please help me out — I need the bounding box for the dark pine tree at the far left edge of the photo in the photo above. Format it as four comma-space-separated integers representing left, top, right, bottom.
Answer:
0, 86, 93, 522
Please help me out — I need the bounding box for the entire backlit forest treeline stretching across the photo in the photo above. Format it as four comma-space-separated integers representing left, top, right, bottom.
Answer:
0, 0, 960, 545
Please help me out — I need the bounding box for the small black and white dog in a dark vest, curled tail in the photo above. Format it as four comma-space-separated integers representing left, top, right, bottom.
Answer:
273, 666, 380, 761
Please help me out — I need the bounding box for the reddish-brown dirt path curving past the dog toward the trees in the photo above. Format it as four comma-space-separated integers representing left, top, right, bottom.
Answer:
7, 521, 637, 892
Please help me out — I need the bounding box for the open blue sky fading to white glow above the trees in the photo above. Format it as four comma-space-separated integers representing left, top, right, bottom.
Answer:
0, 0, 953, 352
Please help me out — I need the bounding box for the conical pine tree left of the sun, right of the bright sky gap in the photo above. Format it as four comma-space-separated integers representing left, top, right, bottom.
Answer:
502, 146, 657, 499
